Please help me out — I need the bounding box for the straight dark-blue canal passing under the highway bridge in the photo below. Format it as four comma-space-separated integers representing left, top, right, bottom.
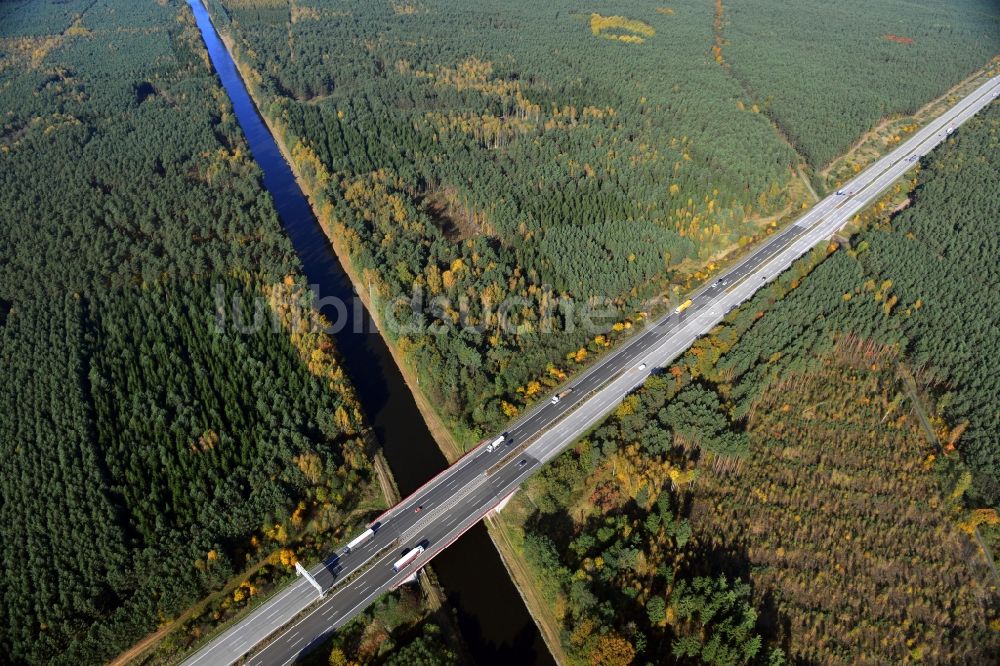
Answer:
188, 0, 553, 666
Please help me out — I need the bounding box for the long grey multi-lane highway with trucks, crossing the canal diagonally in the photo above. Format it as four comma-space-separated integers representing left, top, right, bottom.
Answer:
184, 66, 1000, 666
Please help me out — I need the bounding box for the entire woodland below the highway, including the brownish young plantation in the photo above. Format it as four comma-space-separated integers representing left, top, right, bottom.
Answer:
506, 97, 1000, 663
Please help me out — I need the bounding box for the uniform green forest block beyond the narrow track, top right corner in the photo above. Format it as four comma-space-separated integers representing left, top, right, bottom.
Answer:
718, 0, 1000, 169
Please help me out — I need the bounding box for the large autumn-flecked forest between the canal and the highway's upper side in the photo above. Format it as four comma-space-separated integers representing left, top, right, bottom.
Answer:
208, 0, 996, 443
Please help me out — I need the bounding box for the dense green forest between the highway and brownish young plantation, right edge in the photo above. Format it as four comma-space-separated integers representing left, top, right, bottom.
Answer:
705, 104, 1000, 506
